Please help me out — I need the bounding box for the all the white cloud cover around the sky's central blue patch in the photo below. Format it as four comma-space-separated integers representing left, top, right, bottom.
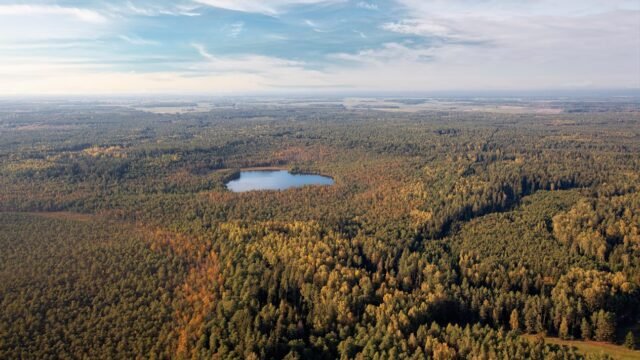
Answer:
0, 0, 640, 94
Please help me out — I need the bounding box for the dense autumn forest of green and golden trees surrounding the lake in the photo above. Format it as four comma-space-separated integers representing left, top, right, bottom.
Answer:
0, 97, 640, 359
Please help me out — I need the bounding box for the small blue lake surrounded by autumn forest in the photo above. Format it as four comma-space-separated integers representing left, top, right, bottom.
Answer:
226, 170, 334, 192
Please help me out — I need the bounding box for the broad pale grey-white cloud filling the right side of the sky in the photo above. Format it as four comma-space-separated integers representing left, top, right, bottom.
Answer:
364, 0, 640, 89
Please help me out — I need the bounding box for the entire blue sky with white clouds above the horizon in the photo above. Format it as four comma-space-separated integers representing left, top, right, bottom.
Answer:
0, 0, 640, 95
